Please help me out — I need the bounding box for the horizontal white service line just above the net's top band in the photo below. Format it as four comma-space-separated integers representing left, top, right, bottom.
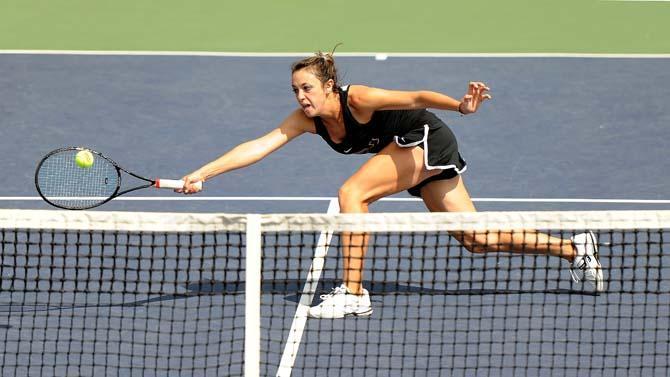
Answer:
0, 196, 670, 204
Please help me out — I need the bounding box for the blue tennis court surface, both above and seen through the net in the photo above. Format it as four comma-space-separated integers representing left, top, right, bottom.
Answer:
0, 54, 670, 376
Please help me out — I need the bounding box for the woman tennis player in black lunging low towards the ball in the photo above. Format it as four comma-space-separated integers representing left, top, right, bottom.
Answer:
178, 48, 604, 318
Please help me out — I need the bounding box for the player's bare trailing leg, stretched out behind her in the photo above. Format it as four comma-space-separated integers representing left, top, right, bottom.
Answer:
421, 176, 575, 262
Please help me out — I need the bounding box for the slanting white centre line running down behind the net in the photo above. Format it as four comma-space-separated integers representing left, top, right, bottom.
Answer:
277, 199, 340, 377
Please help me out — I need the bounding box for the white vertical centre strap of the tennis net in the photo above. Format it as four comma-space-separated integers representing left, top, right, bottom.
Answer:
244, 215, 262, 377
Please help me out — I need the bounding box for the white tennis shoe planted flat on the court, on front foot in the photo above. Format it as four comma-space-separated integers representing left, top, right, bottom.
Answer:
307, 284, 372, 318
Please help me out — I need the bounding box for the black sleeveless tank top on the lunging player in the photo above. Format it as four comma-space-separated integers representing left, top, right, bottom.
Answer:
314, 85, 441, 154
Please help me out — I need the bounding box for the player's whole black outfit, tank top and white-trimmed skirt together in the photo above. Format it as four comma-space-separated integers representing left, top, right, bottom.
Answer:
314, 85, 466, 197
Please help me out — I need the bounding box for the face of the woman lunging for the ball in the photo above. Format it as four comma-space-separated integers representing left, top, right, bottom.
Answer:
291, 68, 332, 118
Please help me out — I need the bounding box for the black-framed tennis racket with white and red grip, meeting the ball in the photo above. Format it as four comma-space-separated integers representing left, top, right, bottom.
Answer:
35, 147, 202, 209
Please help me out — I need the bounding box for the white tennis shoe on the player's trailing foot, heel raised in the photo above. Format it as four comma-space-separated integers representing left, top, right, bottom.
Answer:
570, 232, 605, 292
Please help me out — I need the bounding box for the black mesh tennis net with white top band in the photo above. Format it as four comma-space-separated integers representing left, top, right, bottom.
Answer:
0, 210, 670, 376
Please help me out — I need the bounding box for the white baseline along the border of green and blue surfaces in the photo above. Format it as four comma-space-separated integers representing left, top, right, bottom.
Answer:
0, 50, 670, 59
